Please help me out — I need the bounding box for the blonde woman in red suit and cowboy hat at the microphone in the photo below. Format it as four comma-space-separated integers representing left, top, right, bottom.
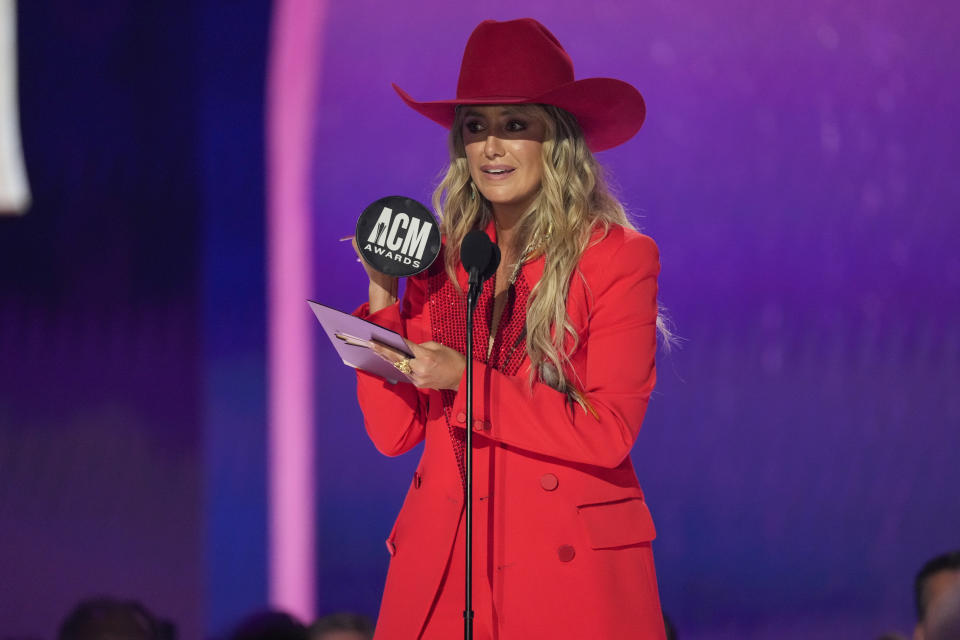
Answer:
357, 19, 664, 640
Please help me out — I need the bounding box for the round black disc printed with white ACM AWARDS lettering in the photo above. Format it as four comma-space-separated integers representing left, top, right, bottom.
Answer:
356, 196, 440, 276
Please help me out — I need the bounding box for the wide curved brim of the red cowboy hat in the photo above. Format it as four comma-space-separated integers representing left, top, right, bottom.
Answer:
393, 78, 647, 151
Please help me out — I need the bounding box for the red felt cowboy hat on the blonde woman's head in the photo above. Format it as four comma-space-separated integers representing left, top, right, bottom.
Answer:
393, 18, 647, 151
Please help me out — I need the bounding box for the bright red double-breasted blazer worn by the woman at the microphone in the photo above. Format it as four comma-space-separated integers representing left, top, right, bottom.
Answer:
357, 226, 664, 640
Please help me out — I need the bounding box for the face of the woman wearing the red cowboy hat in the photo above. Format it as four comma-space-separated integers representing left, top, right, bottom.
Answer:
462, 105, 546, 214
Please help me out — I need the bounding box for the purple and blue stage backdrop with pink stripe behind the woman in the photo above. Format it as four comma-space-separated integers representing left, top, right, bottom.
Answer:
0, 0, 960, 640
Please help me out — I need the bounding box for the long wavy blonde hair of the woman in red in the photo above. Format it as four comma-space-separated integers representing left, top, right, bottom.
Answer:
433, 104, 633, 393
